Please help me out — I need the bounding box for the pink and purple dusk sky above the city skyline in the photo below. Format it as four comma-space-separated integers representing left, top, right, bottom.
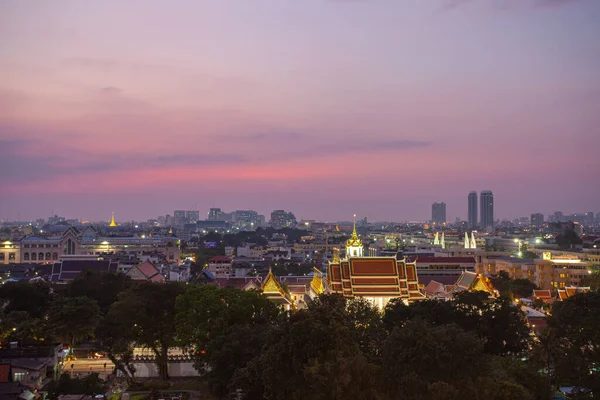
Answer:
0, 0, 600, 221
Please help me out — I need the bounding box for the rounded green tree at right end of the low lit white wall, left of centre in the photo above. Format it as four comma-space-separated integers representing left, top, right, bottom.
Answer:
176, 286, 281, 396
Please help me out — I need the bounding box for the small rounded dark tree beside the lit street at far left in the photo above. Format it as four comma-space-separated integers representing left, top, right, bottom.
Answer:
48, 297, 100, 357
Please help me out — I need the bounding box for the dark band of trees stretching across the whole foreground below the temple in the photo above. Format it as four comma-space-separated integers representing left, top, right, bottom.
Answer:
0, 272, 600, 400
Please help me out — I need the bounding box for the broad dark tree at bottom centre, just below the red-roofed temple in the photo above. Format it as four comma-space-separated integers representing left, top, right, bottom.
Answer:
239, 295, 381, 400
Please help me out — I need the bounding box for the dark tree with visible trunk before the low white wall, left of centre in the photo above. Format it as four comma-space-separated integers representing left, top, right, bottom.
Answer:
99, 283, 185, 379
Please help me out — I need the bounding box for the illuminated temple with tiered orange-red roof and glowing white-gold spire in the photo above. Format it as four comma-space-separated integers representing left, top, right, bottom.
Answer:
327, 219, 425, 308
